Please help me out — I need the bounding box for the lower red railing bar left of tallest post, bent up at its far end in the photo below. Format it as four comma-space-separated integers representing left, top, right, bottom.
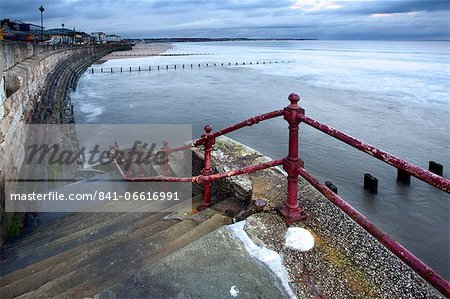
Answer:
113, 159, 283, 184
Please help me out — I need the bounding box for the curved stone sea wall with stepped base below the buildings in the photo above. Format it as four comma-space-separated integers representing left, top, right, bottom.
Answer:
0, 41, 130, 244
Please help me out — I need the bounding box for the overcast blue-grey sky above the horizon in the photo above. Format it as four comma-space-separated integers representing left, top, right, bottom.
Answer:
0, 0, 450, 40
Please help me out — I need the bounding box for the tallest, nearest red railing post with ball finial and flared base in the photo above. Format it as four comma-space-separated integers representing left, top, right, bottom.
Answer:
278, 93, 307, 222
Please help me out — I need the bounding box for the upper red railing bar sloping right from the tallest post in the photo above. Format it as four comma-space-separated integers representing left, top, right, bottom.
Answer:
301, 115, 450, 193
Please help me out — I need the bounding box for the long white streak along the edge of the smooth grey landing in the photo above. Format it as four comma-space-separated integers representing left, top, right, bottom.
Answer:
228, 220, 297, 298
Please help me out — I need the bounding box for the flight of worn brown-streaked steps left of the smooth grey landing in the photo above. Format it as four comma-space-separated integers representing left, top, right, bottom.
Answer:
0, 196, 229, 298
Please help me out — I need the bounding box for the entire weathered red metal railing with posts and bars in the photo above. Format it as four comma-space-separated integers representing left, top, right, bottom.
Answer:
113, 94, 450, 297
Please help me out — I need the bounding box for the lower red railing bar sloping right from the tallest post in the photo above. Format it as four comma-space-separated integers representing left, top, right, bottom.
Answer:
297, 167, 450, 297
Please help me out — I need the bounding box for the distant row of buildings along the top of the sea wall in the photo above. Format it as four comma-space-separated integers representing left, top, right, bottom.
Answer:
0, 19, 123, 45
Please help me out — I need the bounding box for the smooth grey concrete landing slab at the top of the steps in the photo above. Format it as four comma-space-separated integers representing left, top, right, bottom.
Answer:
94, 227, 290, 299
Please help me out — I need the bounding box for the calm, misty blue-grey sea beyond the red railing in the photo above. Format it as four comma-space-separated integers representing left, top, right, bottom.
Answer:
72, 41, 450, 279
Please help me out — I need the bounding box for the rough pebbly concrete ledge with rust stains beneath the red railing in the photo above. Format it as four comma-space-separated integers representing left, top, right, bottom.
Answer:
194, 138, 442, 298
